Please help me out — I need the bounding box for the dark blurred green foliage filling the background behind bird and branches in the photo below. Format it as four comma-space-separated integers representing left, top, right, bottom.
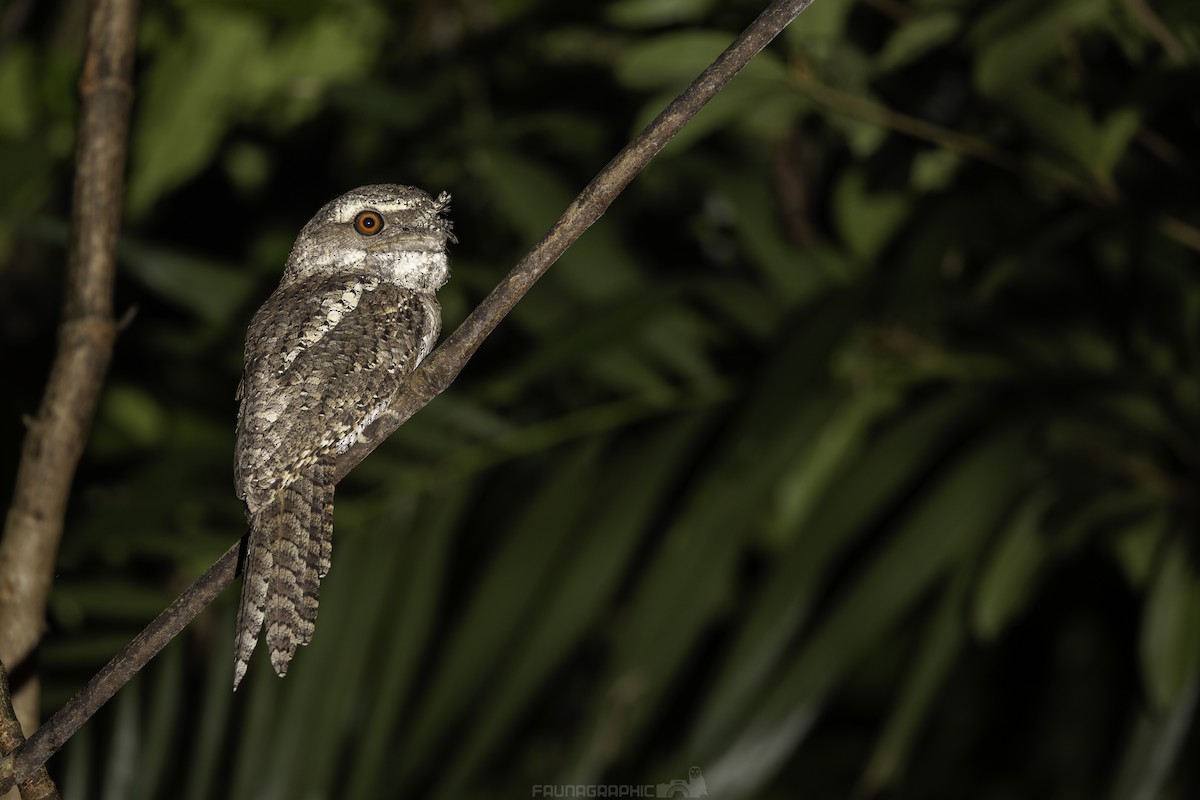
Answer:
0, 0, 1200, 799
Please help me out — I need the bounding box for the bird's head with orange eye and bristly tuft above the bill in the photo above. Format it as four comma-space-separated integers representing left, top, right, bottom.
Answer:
283, 184, 457, 291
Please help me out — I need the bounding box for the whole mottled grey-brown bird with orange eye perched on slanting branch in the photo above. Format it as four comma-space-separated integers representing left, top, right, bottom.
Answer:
234, 184, 454, 688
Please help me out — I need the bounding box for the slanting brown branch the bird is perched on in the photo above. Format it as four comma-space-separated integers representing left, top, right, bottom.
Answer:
0, 0, 812, 789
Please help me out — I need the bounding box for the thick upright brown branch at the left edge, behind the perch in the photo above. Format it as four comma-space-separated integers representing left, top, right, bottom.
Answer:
0, 0, 137, 767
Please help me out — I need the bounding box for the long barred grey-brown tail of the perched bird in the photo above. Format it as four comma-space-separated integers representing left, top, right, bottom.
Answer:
233, 463, 334, 691
